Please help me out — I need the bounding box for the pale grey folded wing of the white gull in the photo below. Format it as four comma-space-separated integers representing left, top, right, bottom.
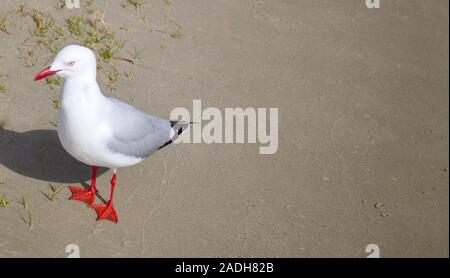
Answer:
107, 98, 171, 158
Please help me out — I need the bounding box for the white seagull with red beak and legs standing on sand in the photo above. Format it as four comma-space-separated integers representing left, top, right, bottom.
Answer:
34, 45, 190, 223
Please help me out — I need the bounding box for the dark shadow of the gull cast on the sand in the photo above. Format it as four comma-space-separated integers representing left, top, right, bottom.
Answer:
0, 129, 108, 187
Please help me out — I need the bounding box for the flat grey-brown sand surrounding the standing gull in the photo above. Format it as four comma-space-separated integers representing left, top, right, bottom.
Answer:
0, 0, 449, 257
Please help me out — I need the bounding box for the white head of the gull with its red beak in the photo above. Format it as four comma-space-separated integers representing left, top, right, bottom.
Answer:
34, 45, 97, 81
